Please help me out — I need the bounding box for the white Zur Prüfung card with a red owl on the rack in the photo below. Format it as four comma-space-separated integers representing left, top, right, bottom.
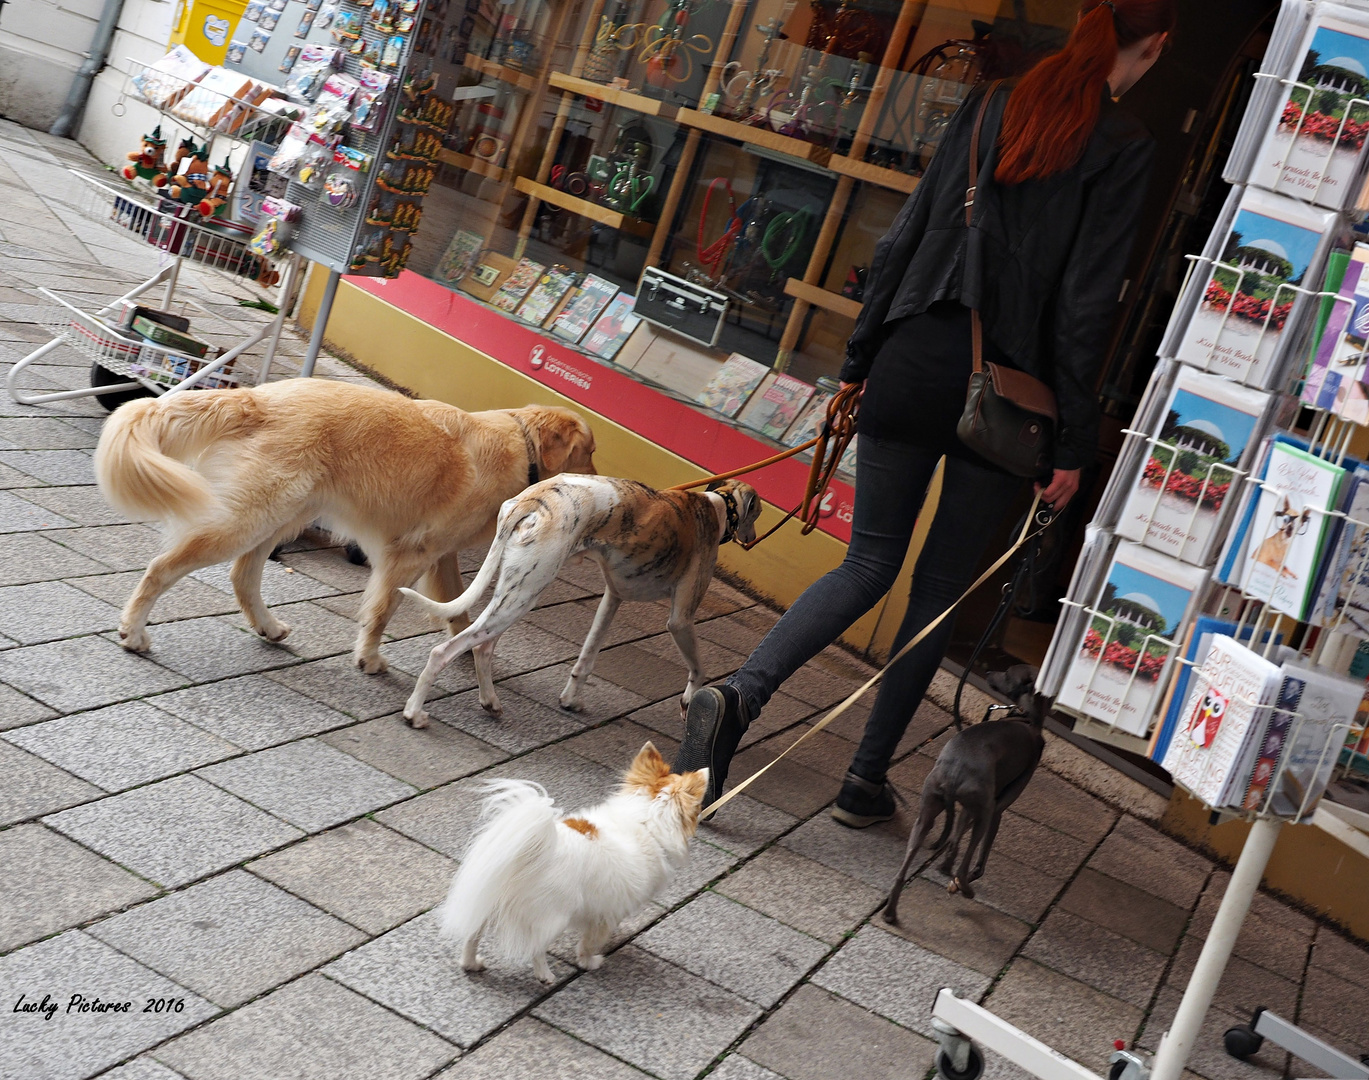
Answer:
1161, 634, 1280, 808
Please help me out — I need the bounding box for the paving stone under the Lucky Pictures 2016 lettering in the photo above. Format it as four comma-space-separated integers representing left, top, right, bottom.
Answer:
0, 931, 218, 1080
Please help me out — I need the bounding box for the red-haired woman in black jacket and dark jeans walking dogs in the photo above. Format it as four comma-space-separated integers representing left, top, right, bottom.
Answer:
675, 0, 1175, 828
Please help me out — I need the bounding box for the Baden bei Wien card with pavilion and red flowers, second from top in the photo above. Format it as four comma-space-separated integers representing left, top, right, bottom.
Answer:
1175, 188, 1336, 387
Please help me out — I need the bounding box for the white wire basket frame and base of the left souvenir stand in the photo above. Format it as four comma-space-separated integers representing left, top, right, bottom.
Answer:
5, 170, 300, 405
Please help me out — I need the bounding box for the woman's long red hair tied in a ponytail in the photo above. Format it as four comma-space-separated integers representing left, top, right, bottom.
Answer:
994, 0, 1175, 183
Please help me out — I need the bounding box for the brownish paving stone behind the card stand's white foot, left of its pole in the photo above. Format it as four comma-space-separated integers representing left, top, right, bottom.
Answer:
984, 960, 1144, 1073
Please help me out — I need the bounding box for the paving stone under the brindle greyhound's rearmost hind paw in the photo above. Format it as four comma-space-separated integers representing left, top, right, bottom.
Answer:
322, 713, 508, 791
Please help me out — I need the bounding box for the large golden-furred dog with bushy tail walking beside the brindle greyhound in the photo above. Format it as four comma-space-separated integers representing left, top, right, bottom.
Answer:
94, 379, 594, 675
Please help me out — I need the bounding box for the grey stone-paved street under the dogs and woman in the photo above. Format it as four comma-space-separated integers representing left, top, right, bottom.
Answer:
0, 122, 1369, 1080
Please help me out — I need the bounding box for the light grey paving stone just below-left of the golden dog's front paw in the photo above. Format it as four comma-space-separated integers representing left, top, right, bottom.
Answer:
151, 675, 355, 750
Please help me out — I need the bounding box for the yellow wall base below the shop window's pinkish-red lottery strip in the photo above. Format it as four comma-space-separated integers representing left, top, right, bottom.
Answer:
298, 271, 941, 658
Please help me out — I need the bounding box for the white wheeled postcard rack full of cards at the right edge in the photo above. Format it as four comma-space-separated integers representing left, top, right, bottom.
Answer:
934, 0, 1369, 1080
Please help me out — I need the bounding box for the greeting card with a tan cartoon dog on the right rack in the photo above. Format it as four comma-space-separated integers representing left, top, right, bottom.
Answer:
1239, 441, 1346, 619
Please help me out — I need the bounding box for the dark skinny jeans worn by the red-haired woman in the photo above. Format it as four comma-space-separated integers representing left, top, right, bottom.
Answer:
727, 435, 1025, 783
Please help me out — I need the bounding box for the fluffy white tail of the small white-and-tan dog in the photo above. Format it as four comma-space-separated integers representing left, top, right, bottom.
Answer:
441, 780, 564, 962
